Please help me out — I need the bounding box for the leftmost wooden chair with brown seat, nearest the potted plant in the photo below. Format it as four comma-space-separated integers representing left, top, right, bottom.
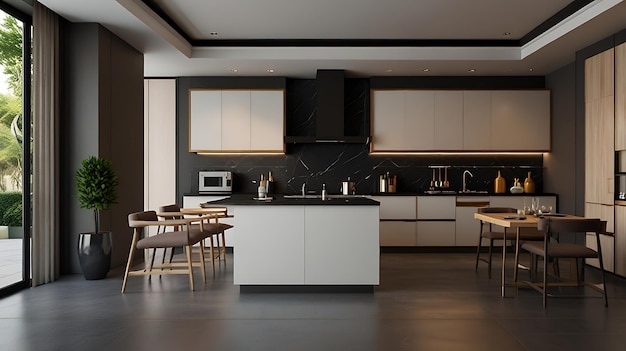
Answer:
122, 211, 208, 293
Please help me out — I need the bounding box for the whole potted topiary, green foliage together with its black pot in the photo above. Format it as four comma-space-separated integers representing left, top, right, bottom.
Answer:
76, 156, 119, 280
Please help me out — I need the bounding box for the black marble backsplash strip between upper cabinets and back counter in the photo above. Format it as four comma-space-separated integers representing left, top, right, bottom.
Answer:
188, 144, 543, 194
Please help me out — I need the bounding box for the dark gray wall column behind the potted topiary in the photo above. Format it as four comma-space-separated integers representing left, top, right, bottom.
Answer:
60, 22, 143, 273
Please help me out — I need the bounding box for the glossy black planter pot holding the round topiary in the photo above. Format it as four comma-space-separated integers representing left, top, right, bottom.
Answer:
78, 232, 113, 280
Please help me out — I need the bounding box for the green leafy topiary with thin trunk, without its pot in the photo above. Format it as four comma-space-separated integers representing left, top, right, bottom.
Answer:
76, 156, 119, 234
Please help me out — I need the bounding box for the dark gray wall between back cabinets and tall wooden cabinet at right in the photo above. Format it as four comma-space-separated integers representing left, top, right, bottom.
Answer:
543, 63, 584, 214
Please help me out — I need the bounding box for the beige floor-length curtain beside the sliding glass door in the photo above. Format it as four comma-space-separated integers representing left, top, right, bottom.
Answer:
32, 1, 60, 286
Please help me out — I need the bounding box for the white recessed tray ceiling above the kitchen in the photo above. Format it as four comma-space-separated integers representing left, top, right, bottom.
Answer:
39, 0, 626, 78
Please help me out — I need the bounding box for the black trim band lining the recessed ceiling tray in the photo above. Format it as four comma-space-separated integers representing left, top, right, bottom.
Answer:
141, 0, 594, 47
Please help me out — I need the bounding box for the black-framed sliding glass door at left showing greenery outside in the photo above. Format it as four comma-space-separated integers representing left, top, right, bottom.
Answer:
0, 2, 31, 296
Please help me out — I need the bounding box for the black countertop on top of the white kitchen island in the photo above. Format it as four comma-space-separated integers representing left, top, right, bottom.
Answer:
210, 194, 380, 206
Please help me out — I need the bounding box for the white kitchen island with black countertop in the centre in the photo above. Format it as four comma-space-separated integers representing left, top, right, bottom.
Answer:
207, 195, 380, 292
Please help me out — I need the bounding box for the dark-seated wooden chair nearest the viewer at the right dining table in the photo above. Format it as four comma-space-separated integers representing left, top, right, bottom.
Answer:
515, 217, 608, 308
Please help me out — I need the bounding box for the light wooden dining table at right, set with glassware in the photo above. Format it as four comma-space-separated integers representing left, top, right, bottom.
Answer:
474, 212, 581, 297
